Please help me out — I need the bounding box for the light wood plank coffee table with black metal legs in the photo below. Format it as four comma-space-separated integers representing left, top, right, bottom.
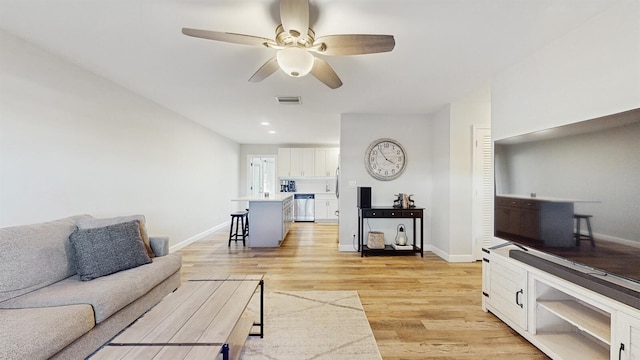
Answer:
92, 275, 264, 360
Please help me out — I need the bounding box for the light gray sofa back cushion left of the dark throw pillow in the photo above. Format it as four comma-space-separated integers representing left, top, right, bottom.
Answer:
0, 215, 91, 302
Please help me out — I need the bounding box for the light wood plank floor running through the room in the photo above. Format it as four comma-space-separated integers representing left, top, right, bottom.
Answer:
180, 223, 547, 360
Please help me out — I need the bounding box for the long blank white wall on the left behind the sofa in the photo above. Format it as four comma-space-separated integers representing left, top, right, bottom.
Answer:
0, 32, 239, 245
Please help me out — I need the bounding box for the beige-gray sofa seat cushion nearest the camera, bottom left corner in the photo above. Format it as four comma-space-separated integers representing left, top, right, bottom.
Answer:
0, 304, 95, 359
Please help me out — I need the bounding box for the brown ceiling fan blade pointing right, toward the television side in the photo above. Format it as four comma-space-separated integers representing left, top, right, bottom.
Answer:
313, 34, 396, 56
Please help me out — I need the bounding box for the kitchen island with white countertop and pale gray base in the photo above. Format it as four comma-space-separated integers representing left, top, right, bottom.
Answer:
231, 193, 293, 247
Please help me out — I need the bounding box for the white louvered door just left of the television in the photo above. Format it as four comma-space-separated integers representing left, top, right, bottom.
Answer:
471, 127, 494, 260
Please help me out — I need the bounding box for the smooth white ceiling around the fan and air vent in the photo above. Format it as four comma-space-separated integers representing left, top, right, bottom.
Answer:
0, 0, 629, 144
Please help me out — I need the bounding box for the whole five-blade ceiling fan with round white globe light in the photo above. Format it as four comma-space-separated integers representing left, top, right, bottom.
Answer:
182, 0, 396, 89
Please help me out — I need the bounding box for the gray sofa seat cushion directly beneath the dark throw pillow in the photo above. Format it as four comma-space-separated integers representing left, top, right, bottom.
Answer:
0, 253, 182, 323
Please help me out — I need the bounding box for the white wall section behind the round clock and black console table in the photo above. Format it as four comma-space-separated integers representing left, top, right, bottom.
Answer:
339, 114, 432, 251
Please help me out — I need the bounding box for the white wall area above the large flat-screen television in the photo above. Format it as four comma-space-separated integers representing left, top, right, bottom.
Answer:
491, 0, 640, 140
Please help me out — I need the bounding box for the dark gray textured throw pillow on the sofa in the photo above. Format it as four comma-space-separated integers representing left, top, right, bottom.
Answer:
69, 220, 151, 281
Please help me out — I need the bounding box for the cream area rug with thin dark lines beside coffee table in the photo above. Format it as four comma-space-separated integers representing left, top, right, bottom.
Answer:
240, 291, 382, 360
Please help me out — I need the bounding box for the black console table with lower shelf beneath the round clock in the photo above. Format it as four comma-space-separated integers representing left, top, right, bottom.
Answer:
358, 207, 424, 257
